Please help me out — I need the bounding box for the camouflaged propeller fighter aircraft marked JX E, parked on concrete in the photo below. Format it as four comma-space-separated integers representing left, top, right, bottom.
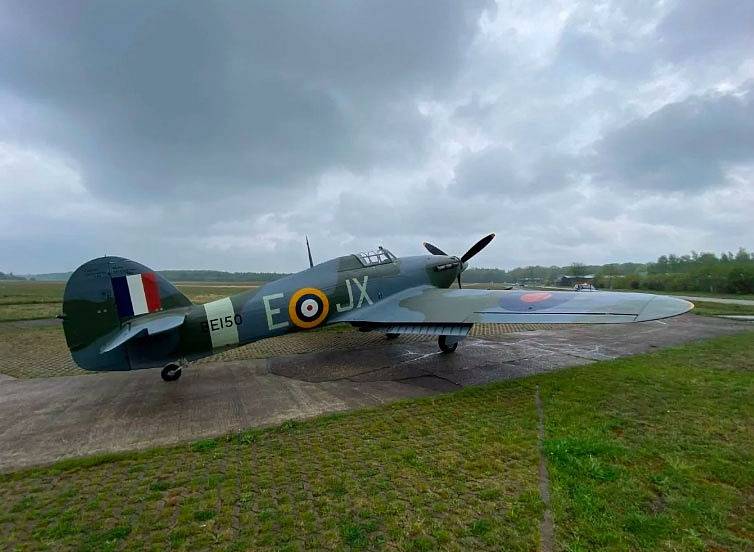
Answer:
61, 234, 693, 381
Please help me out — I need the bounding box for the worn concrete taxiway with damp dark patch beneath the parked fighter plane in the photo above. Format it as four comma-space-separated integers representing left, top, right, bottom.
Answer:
0, 314, 751, 471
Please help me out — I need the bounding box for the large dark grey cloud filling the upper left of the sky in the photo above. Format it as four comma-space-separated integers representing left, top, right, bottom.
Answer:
0, 2, 485, 202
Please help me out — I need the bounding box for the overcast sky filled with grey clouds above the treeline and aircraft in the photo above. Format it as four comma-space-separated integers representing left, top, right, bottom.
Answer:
0, 0, 754, 274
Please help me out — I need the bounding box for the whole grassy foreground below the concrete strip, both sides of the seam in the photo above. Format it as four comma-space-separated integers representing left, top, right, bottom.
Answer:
0, 332, 754, 551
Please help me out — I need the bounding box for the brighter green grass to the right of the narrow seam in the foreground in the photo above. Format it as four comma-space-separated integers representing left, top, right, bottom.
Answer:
542, 333, 754, 550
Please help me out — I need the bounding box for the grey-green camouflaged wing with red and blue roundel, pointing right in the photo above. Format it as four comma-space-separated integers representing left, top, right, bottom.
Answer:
337, 286, 694, 327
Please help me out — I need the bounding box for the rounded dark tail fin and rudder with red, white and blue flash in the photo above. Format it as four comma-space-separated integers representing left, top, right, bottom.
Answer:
63, 257, 191, 370
